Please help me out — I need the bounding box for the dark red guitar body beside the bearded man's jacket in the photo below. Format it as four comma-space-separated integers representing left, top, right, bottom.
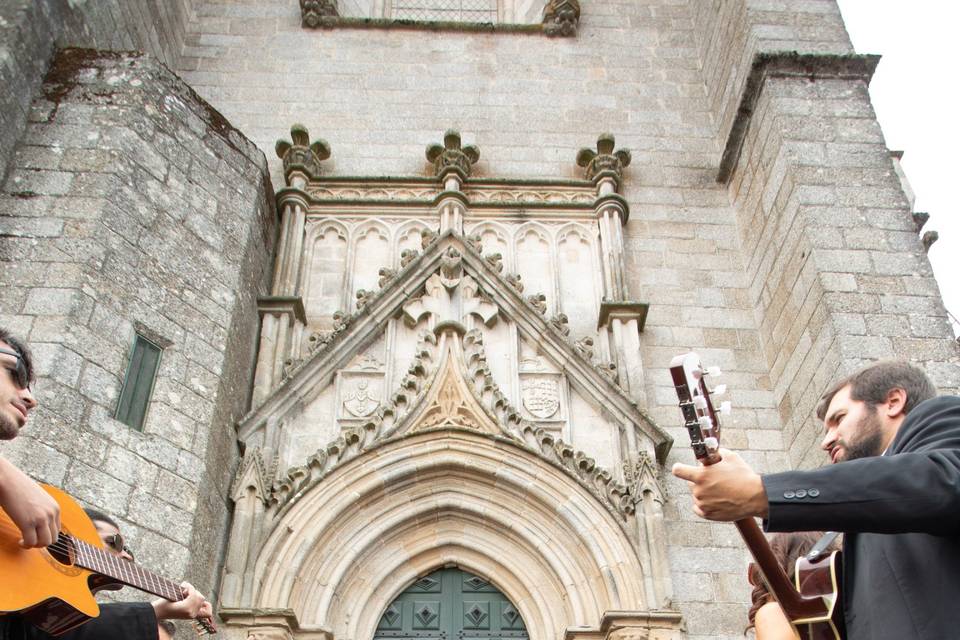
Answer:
792, 551, 846, 640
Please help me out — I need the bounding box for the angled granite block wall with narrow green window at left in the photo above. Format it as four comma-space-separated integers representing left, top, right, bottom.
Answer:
0, 49, 276, 592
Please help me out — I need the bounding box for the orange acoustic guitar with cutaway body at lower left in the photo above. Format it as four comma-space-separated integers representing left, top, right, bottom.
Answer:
0, 485, 217, 635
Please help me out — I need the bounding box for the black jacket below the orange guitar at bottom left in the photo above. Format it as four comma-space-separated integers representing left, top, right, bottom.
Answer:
0, 602, 158, 640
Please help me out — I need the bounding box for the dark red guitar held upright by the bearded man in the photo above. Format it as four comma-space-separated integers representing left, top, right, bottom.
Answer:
670, 353, 845, 640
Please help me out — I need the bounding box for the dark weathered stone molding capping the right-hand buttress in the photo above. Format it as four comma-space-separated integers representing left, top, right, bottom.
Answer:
717, 51, 880, 184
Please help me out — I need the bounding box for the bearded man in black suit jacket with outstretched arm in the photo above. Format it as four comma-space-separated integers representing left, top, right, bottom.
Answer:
673, 362, 960, 640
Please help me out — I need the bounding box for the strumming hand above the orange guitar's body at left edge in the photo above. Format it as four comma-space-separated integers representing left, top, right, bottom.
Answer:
0, 456, 60, 548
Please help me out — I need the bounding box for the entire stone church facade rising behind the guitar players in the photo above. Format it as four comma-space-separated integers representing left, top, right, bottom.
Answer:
0, 0, 960, 640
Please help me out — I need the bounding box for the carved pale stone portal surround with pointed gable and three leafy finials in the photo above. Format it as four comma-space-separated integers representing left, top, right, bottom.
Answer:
223, 127, 672, 637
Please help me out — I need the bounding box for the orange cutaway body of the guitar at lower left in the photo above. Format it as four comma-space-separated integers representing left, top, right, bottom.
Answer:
0, 485, 103, 635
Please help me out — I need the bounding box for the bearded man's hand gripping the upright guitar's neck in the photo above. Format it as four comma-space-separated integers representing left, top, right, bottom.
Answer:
672, 449, 769, 522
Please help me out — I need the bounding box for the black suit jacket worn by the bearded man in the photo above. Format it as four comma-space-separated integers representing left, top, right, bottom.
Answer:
763, 396, 960, 640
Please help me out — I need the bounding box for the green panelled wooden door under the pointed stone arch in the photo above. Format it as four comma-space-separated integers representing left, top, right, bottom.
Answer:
374, 569, 527, 640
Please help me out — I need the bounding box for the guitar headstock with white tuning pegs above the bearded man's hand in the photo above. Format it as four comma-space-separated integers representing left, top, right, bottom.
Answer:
670, 352, 730, 464
